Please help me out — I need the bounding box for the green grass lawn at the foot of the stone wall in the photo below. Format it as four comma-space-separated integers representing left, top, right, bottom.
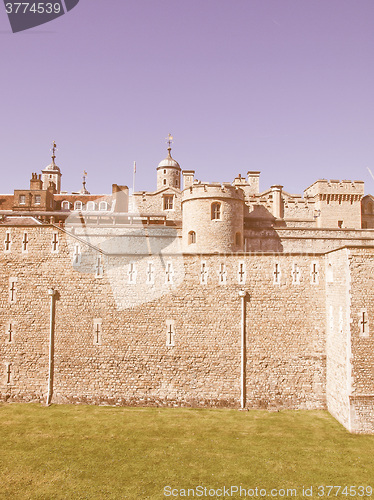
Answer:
0, 404, 374, 500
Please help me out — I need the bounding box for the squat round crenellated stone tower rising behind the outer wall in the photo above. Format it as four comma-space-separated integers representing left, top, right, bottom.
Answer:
182, 184, 244, 253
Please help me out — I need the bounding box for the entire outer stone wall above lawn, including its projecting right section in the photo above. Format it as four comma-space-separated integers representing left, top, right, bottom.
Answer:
0, 225, 374, 432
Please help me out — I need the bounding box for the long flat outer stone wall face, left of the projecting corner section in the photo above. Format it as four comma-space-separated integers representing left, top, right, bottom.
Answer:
0, 226, 325, 408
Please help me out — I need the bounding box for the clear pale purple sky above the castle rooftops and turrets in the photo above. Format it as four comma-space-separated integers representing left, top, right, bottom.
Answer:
0, 0, 374, 193
